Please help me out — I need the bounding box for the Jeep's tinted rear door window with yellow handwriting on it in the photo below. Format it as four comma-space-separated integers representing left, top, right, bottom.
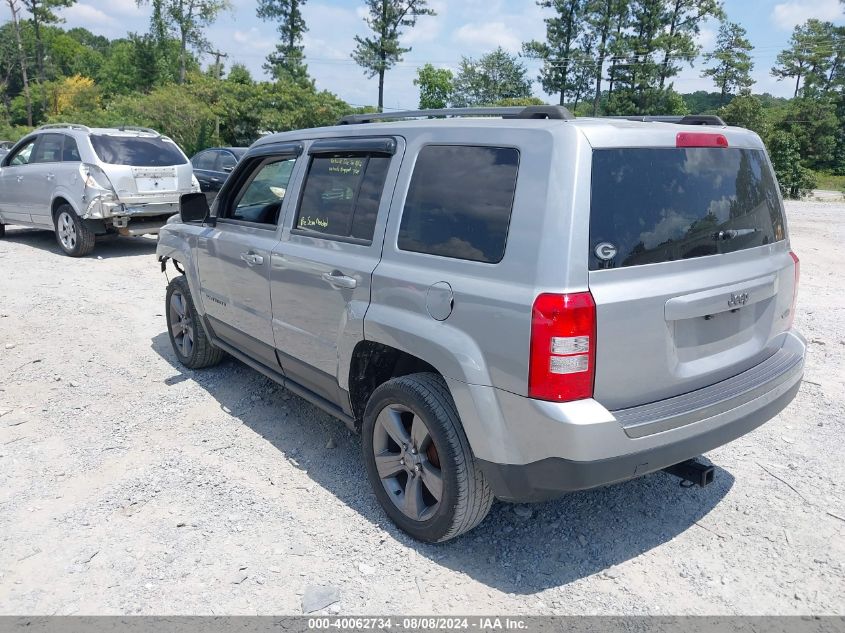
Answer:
295, 155, 390, 241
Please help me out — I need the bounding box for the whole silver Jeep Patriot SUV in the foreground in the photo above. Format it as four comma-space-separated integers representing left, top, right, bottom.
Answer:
158, 107, 805, 541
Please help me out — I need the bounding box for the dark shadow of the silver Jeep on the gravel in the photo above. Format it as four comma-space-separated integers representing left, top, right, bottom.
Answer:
152, 332, 734, 595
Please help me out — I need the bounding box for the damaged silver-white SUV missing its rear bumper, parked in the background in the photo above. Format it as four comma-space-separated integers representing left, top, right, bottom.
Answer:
0, 123, 199, 257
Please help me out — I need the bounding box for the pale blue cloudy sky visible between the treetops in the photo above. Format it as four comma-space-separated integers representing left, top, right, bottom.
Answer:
52, 0, 845, 109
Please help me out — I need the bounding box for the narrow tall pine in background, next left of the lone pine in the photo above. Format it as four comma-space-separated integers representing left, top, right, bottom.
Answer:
258, 0, 308, 81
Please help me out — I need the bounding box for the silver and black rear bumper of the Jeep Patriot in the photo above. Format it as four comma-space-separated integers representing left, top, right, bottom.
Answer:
450, 331, 806, 501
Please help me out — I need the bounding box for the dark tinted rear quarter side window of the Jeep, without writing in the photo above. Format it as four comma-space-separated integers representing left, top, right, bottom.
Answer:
399, 145, 519, 263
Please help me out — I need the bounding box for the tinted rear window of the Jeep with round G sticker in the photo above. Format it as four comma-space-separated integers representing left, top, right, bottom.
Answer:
590, 148, 786, 270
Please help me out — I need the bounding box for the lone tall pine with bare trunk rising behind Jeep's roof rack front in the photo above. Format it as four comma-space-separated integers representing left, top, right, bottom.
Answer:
352, 0, 435, 112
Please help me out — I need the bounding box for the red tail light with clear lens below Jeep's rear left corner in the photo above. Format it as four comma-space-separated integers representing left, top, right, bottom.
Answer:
528, 292, 596, 402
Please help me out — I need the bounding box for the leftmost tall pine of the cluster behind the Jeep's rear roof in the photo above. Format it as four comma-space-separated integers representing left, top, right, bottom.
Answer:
522, 0, 584, 105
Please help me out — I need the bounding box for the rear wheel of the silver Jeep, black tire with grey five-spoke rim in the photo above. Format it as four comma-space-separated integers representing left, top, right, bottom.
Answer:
362, 373, 493, 543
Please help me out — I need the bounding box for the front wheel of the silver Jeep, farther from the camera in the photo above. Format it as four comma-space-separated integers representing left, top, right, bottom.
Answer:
164, 275, 223, 369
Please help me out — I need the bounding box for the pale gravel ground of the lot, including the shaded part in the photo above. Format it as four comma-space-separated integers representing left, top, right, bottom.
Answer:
0, 202, 845, 614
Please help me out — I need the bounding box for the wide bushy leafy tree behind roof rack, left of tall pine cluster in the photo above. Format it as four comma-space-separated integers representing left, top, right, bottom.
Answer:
452, 47, 531, 107
